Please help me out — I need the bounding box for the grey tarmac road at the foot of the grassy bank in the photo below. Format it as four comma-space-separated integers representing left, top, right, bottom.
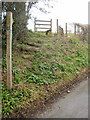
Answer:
37, 80, 88, 118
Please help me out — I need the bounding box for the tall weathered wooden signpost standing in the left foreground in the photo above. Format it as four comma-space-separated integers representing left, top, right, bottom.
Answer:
6, 12, 13, 89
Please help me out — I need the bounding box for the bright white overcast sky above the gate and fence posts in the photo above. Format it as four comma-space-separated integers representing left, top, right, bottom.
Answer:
28, 0, 89, 32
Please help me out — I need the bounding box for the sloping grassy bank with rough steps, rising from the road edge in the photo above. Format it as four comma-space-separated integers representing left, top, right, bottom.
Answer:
2, 32, 88, 116
